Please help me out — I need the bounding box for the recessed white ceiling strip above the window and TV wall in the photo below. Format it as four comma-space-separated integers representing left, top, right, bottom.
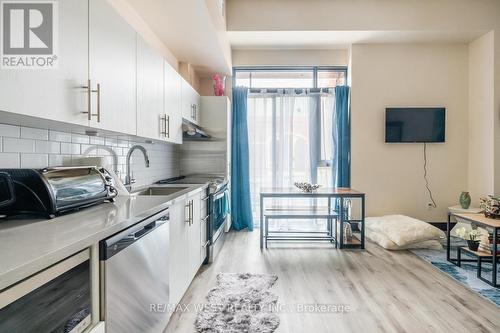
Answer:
227, 31, 484, 49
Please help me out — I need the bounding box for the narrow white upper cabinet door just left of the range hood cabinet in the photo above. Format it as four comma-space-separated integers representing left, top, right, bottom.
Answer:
164, 61, 182, 144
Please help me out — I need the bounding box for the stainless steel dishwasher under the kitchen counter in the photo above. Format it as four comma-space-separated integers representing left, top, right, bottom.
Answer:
100, 210, 169, 333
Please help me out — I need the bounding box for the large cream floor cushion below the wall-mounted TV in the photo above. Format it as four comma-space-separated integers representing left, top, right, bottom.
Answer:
365, 215, 445, 246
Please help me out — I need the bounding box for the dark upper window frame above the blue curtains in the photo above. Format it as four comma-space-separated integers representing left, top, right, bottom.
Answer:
232, 66, 348, 89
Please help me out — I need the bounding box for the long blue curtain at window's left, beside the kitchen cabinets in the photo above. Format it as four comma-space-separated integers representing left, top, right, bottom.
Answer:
231, 87, 253, 230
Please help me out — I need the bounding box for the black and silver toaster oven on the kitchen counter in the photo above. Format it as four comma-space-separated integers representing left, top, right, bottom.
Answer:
0, 167, 117, 218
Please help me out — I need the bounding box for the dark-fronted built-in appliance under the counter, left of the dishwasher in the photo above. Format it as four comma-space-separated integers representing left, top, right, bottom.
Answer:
0, 250, 92, 333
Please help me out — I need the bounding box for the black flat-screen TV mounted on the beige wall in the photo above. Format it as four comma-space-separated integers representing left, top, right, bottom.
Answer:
385, 108, 446, 142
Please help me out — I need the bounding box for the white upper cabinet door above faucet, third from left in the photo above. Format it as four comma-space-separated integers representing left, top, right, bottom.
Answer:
137, 36, 164, 140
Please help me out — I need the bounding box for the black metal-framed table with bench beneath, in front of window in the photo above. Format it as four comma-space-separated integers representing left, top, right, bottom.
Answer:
260, 187, 365, 249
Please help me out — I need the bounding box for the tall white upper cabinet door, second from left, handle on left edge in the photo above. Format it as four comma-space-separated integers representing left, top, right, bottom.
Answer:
89, 0, 136, 134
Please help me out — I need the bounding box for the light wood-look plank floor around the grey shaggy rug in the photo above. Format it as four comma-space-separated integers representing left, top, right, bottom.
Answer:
165, 231, 500, 333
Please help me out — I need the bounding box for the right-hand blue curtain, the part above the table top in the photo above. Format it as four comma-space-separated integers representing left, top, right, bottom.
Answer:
333, 86, 351, 187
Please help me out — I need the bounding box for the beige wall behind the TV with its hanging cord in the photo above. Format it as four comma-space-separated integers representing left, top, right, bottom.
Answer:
351, 44, 469, 221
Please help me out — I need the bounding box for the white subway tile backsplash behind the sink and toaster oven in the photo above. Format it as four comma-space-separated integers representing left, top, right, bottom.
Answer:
0, 124, 180, 186
